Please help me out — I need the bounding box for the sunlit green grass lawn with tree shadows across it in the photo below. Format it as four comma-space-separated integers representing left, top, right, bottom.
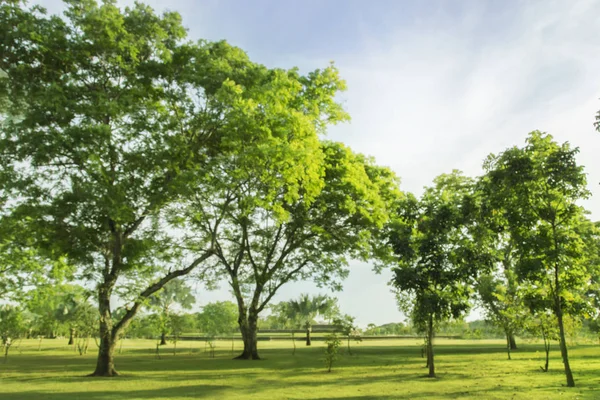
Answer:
0, 339, 600, 400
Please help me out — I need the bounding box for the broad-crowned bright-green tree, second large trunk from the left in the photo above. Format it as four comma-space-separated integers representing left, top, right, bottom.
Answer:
183, 138, 398, 359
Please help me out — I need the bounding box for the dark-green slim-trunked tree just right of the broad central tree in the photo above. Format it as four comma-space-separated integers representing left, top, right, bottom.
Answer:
390, 171, 493, 377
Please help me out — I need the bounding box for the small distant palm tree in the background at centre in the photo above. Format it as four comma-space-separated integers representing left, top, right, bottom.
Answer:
287, 294, 338, 346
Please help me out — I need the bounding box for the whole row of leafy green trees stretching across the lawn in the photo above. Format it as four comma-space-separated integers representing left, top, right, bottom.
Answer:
0, 0, 600, 386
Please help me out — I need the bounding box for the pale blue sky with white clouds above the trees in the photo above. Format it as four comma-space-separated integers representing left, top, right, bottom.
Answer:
37, 0, 600, 327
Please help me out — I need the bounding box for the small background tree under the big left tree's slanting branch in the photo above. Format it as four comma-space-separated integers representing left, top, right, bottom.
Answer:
149, 279, 196, 346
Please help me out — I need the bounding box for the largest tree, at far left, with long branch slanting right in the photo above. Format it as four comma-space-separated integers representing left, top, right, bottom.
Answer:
0, 0, 272, 376
